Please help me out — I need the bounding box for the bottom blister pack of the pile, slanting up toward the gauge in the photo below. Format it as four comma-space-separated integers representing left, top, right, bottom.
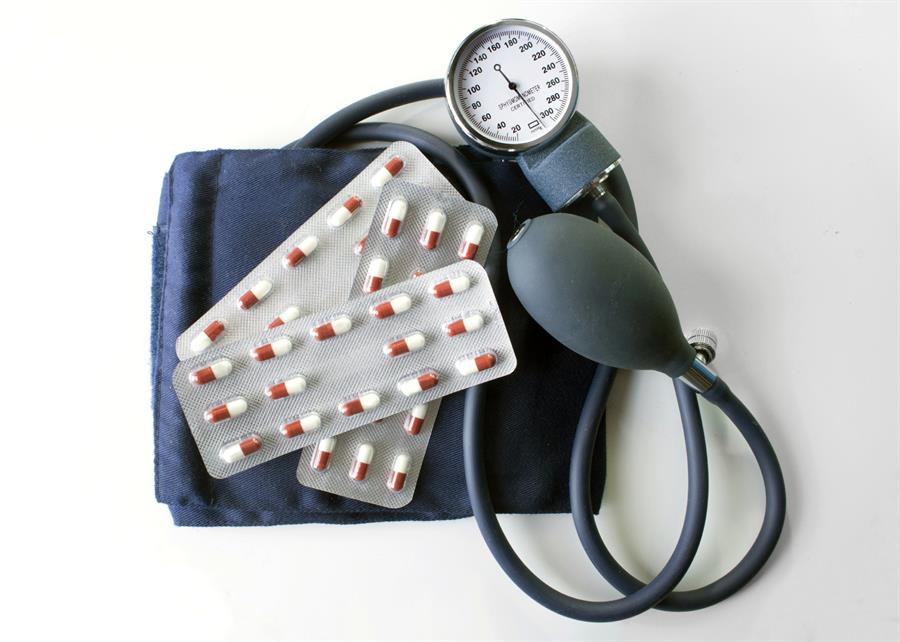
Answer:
175, 142, 457, 360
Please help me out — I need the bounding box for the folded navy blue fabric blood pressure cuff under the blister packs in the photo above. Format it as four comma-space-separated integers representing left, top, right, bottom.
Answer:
151, 148, 605, 526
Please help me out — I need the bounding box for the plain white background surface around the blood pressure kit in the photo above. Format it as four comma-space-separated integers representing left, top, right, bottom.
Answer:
0, 1, 900, 640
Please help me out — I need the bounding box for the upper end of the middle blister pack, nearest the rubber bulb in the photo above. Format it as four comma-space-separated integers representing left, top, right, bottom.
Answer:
351, 180, 497, 296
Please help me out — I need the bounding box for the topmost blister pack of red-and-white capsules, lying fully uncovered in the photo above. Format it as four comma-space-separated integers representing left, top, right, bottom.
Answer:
172, 261, 516, 478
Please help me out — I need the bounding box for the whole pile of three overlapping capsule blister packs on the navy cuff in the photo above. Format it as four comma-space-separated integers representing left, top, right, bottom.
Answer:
172, 142, 516, 508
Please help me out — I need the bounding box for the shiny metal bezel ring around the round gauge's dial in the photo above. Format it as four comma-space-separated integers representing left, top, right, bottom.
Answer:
444, 18, 579, 154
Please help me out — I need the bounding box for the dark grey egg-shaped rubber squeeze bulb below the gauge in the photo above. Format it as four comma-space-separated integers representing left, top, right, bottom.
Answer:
507, 213, 696, 377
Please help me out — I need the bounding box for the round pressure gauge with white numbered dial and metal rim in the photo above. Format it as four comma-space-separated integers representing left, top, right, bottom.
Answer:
444, 20, 578, 153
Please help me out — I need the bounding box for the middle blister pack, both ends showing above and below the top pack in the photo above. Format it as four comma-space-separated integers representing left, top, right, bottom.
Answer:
297, 180, 497, 508
